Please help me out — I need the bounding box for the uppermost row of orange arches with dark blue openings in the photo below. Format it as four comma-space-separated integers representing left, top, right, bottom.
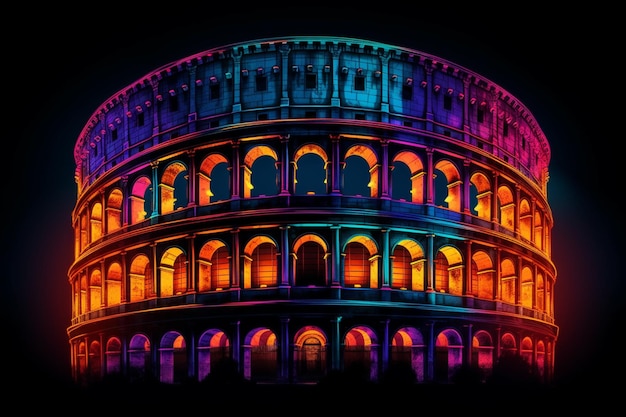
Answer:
75, 138, 550, 256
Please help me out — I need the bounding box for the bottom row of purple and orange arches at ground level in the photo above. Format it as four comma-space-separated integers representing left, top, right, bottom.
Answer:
72, 319, 553, 384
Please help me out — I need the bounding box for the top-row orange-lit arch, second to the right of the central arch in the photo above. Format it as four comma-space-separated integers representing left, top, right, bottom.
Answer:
391, 151, 426, 204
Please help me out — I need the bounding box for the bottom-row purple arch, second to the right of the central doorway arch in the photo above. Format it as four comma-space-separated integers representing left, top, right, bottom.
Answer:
389, 327, 426, 382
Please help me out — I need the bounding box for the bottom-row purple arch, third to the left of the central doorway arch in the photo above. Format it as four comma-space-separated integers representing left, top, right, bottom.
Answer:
159, 331, 188, 384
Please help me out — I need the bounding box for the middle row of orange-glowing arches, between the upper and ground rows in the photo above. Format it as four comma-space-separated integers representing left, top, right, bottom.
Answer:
72, 227, 554, 317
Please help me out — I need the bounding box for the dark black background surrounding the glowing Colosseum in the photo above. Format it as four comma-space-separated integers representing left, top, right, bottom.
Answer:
6, 1, 624, 406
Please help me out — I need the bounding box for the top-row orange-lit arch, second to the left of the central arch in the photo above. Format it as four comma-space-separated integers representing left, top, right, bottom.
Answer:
198, 153, 231, 205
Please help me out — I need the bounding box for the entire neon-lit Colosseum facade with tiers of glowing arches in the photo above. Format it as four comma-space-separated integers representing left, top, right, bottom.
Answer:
68, 37, 558, 383
